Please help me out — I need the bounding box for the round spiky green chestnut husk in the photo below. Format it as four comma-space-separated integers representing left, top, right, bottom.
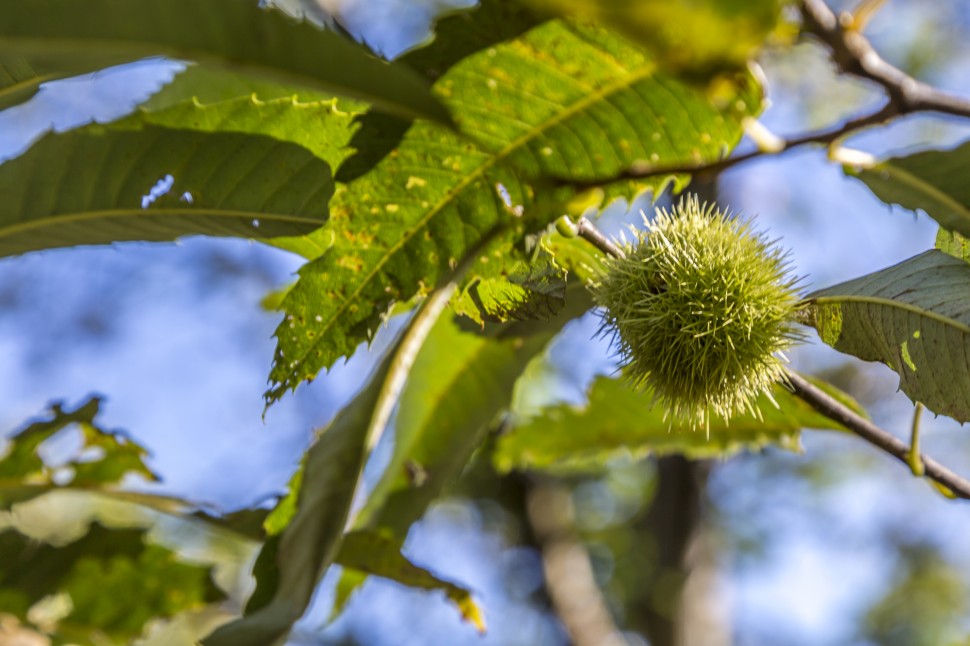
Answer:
593, 196, 799, 427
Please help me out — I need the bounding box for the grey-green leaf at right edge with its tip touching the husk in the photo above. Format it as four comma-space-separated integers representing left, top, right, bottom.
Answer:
806, 249, 970, 422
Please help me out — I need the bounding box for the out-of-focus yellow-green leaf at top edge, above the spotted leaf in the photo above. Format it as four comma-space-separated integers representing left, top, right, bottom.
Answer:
526, 0, 783, 75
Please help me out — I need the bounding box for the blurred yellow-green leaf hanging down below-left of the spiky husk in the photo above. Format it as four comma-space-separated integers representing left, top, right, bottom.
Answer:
354, 291, 591, 539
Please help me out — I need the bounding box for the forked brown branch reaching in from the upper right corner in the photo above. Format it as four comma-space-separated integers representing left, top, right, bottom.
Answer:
554, 0, 970, 189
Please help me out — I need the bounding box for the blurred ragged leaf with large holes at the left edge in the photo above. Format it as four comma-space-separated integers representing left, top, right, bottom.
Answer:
0, 397, 158, 496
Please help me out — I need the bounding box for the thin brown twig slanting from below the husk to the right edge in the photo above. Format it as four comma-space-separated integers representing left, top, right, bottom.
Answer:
785, 371, 970, 500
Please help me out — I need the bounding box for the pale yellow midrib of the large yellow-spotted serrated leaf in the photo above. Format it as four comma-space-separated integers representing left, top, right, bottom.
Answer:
287, 61, 656, 381
